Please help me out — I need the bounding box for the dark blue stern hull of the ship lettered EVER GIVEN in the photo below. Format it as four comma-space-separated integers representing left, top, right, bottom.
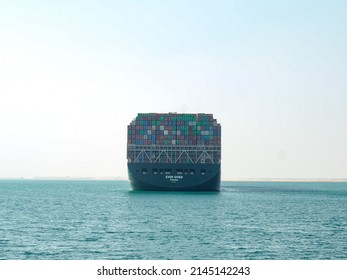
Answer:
128, 163, 221, 192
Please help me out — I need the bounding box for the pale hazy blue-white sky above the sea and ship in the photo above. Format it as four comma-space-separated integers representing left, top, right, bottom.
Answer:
0, 0, 347, 179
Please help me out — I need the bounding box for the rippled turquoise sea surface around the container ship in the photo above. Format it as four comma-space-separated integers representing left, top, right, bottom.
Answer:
0, 180, 347, 260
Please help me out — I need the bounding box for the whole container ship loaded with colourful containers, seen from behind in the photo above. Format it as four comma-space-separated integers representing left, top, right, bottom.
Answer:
127, 113, 221, 191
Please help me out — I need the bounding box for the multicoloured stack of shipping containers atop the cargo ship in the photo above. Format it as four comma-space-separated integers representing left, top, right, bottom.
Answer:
128, 113, 221, 147
